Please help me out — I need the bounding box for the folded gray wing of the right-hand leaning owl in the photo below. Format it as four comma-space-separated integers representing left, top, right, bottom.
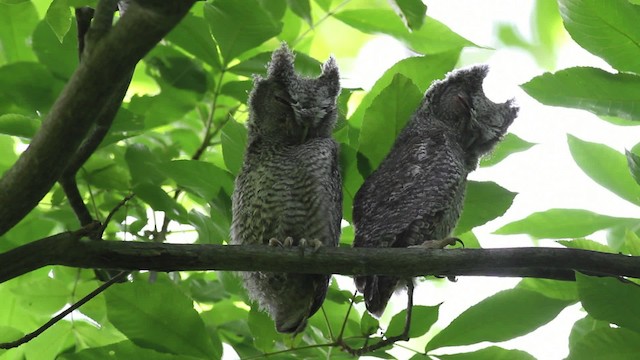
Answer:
354, 134, 466, 247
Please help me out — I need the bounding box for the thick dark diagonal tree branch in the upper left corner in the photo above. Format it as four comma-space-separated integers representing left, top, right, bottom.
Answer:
0, 0, 195, 235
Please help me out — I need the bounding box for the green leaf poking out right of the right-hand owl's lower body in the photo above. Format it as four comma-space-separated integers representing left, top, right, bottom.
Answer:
454, 181, 517, 234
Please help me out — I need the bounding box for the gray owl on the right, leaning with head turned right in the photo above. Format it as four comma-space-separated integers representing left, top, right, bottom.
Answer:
353, 65, 518, 316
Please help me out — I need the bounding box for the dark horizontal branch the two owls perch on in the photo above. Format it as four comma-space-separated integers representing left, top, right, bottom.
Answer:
0, 229, 640, 283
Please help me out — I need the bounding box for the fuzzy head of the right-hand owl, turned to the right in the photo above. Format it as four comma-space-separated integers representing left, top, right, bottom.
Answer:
426, 65, 518, 152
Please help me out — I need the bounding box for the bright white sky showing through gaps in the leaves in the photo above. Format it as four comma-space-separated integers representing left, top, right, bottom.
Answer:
339, 0, 640, 360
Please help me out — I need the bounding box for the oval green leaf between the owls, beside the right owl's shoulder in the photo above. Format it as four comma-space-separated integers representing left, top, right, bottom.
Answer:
358, 74, 422, 172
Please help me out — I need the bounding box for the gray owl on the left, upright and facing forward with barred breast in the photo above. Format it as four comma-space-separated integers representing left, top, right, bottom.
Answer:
231, 44, 342, 333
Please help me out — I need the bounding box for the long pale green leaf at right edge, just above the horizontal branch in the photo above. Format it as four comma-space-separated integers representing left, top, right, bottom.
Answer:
494, 209, 640, 239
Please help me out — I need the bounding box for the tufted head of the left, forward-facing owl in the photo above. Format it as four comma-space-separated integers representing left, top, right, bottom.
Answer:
249, 45, 340, 145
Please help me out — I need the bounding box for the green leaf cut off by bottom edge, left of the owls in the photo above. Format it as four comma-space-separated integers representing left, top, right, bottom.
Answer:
57, 341, 203, 360
